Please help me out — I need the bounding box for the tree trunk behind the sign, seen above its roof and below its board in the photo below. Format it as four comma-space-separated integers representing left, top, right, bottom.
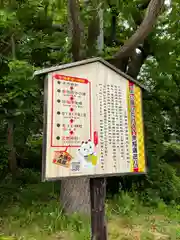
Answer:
60, 0, 90, 215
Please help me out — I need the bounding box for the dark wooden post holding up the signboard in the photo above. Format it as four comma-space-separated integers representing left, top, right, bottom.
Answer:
90, 178, 107, 240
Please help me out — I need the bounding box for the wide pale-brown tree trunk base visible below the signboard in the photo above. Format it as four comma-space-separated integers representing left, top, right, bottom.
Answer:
60, 177, 90, 215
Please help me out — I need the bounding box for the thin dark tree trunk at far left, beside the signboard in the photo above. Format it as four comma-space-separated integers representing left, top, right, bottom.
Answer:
8, 119, 17, 178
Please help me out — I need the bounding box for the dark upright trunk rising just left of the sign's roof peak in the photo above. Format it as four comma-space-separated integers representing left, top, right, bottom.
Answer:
68, 0, 82, 61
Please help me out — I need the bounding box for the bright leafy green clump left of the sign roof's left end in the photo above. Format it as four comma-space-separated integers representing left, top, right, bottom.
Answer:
0, 60, 37, 107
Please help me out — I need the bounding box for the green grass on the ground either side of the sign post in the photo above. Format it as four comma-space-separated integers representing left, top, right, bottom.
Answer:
0, 171, 180, 240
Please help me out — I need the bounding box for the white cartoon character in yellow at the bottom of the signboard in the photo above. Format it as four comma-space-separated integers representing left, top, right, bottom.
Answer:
78, 140, 97, 166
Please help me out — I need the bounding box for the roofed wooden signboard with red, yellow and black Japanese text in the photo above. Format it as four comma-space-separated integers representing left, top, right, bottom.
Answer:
36, 59, 146, 180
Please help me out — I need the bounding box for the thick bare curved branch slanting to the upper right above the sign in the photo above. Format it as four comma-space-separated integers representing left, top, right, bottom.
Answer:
114, 0, 164, 59
